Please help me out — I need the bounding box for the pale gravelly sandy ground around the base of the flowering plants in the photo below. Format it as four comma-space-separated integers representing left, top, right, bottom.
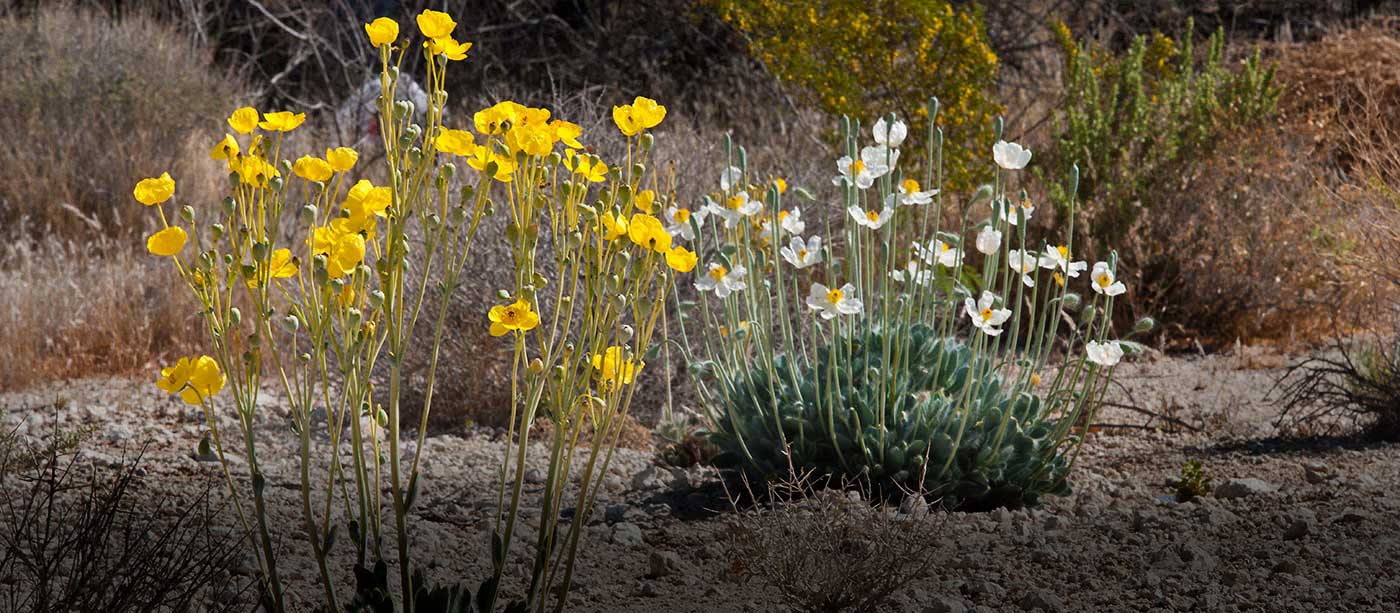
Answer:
0, 351, 1400, 613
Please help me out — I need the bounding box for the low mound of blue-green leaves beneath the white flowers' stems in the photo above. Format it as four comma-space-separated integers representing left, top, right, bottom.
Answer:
711, 323, 1070, 509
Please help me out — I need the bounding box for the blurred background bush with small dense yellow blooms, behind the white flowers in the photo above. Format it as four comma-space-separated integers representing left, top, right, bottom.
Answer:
706, 0, 998, 188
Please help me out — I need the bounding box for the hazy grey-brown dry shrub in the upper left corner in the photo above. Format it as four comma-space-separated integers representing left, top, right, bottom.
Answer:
0, 3, 241, 244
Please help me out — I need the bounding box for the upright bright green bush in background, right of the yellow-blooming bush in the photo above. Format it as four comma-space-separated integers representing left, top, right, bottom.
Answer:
1051, 21, 1280, 246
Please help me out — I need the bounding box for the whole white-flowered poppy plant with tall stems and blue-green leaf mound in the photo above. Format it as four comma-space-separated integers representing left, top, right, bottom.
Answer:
682, 107, 1141, 508
